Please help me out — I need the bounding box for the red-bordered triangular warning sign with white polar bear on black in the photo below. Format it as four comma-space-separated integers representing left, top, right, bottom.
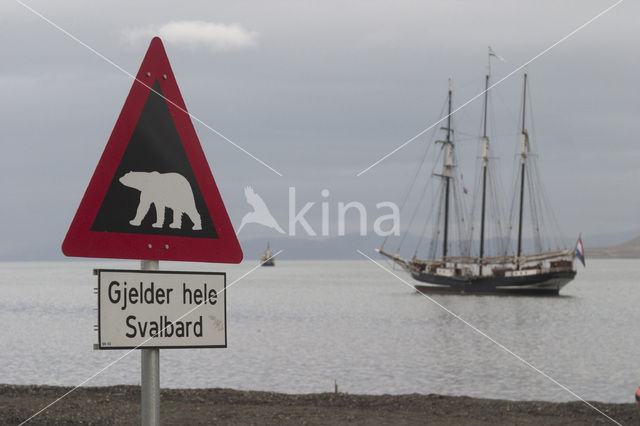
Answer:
62, 37, 242, 263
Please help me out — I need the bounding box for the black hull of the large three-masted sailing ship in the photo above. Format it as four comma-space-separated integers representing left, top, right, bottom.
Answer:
411, 270, 576, 296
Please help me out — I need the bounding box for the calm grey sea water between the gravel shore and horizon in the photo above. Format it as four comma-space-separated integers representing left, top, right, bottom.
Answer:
0, 260, 640, 402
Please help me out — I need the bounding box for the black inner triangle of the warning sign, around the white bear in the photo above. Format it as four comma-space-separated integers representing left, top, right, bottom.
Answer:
91, 80, 218, 238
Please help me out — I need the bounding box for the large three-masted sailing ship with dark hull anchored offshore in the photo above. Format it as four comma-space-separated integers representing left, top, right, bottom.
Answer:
377, 66, 584, 295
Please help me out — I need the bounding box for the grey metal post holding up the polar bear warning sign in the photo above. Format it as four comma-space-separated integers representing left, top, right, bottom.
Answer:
140, 260, 160, 426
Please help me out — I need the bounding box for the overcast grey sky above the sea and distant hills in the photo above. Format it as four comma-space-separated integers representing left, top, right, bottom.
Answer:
0, 0, 640, 258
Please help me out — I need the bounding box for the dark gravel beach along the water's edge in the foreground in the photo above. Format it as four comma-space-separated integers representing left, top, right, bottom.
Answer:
0, 385, 640, 426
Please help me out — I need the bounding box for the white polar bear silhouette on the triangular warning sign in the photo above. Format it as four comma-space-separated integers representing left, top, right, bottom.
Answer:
119, 172, 202, 231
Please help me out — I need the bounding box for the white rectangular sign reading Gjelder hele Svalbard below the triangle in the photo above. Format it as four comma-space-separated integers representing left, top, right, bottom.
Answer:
97, 269, 227, 349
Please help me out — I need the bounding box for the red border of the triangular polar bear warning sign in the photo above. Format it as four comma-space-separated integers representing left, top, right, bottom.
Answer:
62, 37, 243, 263
